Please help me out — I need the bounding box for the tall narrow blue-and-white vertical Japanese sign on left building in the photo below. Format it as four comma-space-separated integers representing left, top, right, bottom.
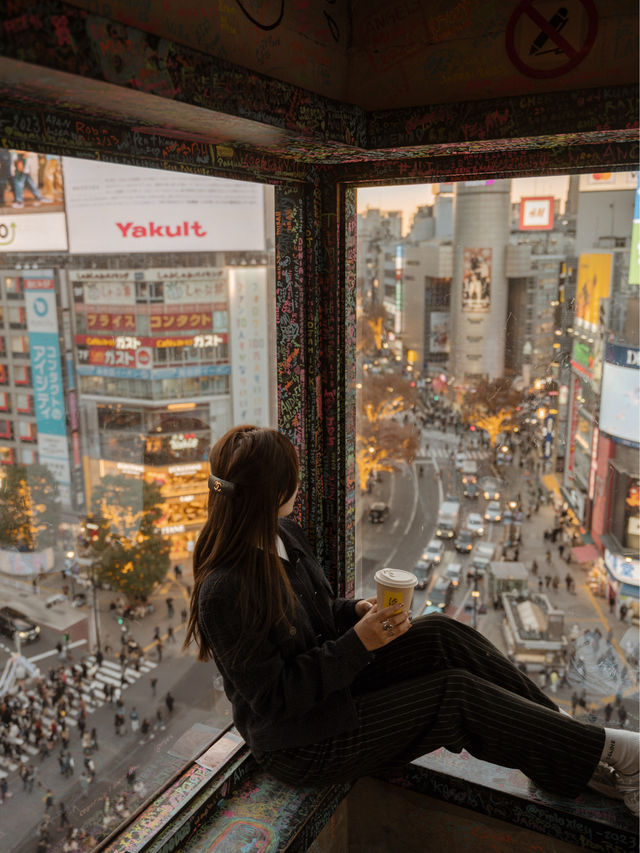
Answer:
24, 270, 71, 503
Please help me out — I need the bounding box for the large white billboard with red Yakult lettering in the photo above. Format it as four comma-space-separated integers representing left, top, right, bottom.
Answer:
63, 157, 265, 253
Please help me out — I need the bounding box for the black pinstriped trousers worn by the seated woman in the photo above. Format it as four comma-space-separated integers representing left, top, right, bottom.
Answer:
259, 614, 604, 797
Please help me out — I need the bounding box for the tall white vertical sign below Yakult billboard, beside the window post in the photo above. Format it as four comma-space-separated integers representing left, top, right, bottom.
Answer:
229, 267, 268, 426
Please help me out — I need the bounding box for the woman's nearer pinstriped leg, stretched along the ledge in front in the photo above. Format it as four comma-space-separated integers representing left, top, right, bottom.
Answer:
264, 664, 604, 797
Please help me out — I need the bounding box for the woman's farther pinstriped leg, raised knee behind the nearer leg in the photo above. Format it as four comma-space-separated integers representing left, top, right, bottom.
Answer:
352, 613, 558, 711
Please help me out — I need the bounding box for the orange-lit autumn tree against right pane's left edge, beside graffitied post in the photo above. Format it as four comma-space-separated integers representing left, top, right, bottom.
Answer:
356, 373, 420, 491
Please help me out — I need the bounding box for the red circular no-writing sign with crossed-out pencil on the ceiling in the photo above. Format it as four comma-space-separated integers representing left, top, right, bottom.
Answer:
506, 0, 598, 79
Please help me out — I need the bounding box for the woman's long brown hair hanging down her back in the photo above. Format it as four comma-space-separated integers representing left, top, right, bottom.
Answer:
183, 424, 299, 661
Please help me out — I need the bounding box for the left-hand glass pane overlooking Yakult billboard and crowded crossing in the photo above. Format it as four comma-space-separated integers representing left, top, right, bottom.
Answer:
0, 151, 277, 851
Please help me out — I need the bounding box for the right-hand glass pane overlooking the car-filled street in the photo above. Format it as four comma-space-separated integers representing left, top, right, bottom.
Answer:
356, 173, 640, 724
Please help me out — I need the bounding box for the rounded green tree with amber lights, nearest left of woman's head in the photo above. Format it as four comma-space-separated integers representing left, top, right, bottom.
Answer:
89, 476, 171, 599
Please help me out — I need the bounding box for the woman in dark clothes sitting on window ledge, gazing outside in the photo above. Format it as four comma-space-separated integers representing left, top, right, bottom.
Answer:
185, 426, 638, 813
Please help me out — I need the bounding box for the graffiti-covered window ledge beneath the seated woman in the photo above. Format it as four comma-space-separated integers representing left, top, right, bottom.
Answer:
98, 747, 638, 853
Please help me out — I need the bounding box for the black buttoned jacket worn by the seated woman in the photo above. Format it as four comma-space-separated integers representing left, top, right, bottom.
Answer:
198, 519, 373, 753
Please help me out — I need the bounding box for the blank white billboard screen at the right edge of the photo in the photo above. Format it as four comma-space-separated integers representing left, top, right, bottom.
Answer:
600, 361, 640, 444
